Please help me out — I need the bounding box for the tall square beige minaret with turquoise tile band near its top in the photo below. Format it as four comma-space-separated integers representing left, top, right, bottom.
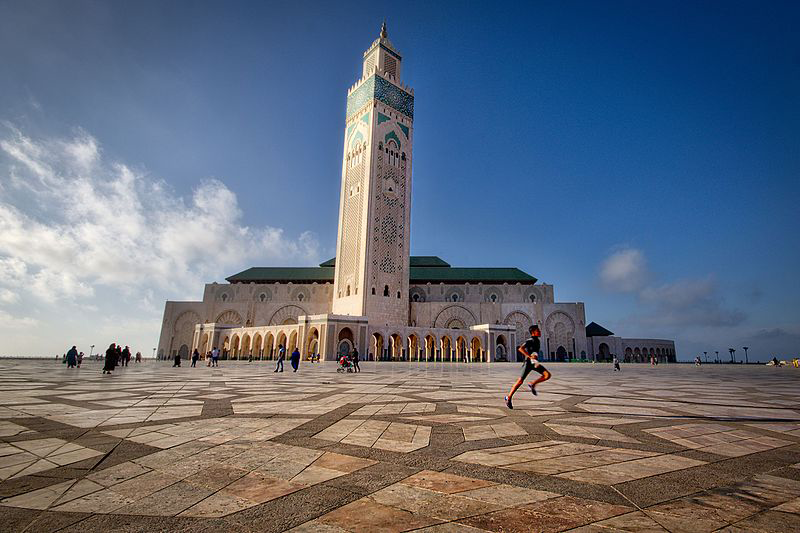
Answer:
333, 22, 414, 326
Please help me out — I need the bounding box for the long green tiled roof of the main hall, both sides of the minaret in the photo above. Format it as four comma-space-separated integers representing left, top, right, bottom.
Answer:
226, 256, 536, 285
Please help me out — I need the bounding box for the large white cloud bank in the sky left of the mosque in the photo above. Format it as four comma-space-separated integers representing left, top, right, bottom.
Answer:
0, 124, 319, 354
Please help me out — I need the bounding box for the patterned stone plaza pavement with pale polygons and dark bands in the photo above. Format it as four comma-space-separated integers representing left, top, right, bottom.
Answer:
0, 360, 800, 533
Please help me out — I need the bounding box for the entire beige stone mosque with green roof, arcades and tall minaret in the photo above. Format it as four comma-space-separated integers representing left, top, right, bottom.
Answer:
158, 24, 675, 363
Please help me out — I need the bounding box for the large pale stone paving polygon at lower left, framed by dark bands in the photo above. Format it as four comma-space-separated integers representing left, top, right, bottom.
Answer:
2, 441, 375, 517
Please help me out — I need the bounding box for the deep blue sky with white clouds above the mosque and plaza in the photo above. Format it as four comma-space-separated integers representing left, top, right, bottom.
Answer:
0, 0, 800, 360
